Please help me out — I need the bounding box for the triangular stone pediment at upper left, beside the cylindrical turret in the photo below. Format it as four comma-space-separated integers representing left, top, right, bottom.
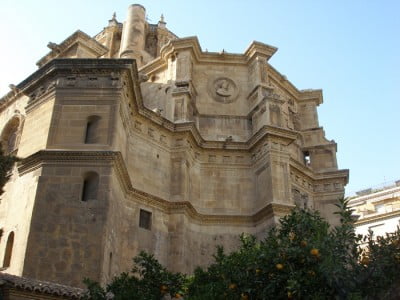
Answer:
36, 30, 108, 67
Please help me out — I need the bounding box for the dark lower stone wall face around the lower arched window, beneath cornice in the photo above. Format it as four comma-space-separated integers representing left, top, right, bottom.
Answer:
22, 162, 111, 286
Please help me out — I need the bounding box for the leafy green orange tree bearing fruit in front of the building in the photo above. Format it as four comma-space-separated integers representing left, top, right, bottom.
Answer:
83, 200, 400, 300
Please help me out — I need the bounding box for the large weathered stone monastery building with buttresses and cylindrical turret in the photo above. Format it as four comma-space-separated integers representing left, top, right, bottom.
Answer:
0, 4, 348, 286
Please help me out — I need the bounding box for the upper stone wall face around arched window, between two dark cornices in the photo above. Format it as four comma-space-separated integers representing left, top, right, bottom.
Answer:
48, 86, 119, 150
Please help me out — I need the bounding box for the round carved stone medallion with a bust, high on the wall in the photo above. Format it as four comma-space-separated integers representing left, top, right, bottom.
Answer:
208, 77, 239, 103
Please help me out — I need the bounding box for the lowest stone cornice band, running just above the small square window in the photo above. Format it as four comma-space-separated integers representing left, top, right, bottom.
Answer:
18, 150, 294, 226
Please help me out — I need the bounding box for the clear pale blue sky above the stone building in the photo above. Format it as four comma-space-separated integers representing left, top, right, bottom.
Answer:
0, 0, 400, 194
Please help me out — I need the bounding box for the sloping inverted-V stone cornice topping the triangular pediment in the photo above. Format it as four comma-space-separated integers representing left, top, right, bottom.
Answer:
36, 30, 108, 67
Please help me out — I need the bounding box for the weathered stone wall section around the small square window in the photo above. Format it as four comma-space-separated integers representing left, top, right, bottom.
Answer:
102, 176, 169, 282
